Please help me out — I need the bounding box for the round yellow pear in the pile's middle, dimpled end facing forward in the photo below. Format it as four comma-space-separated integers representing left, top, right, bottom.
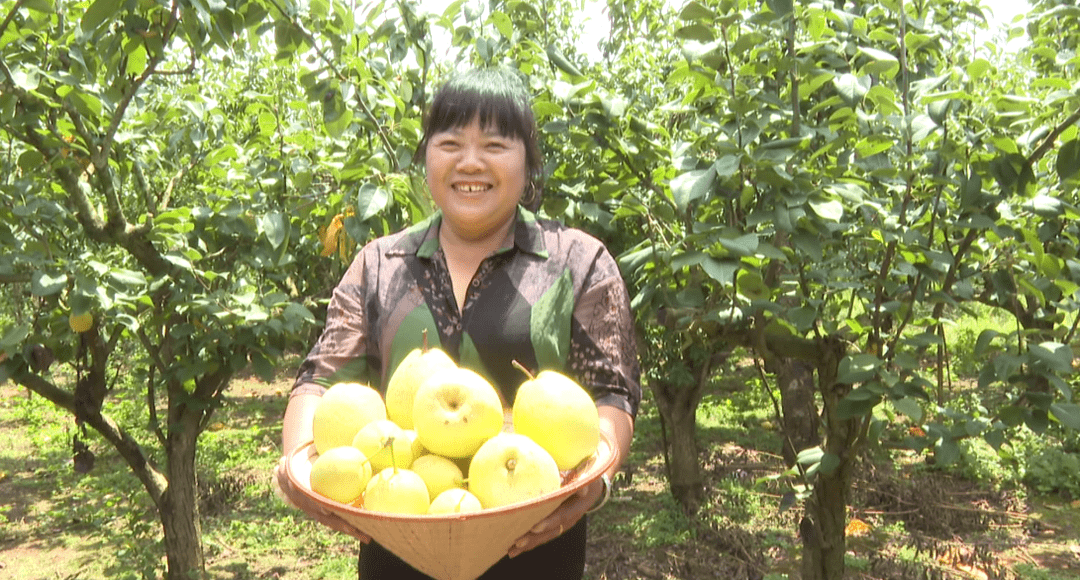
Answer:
413, 367, 502, 458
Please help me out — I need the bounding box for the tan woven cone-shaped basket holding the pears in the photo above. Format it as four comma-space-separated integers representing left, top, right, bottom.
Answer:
287, 433, 616, 580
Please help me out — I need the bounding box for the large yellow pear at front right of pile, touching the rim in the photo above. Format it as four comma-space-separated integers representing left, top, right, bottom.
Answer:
469, 432, 563, 509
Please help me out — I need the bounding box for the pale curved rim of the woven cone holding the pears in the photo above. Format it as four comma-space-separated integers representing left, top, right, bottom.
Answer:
285, 431, 617, 523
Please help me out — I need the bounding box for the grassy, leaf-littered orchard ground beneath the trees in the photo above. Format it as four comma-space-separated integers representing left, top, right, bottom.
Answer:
0, 356, 1080, 580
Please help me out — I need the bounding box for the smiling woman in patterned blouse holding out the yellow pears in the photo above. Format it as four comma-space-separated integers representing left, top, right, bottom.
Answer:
276, 69, 640, 580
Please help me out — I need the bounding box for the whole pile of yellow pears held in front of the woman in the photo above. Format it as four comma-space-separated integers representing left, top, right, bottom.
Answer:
310, 339, 600, 515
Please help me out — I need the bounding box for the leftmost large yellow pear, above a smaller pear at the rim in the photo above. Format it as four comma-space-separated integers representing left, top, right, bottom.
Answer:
311, 382, 387, 454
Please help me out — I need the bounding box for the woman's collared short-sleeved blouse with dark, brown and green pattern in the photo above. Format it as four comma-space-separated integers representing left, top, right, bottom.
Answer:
293, 207, 642, 417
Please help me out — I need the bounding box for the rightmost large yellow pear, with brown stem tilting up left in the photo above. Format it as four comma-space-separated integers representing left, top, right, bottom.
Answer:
512, 370, 600, 471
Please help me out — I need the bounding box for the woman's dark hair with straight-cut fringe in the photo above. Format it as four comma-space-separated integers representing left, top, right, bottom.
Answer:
413, 68, 543, 211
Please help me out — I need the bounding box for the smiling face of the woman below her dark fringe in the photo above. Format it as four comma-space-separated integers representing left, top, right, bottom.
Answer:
426, 119, 528, 242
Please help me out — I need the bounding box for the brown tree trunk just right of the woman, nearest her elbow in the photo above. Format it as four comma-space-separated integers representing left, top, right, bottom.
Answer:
652, 375, 704, 505
